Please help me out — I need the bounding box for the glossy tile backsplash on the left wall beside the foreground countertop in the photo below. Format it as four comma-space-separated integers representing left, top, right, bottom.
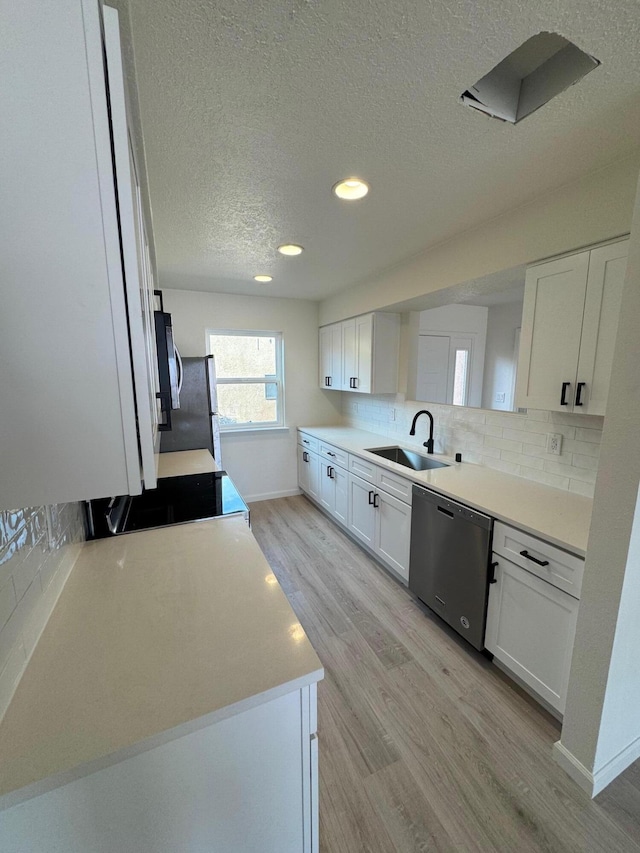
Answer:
0, 504, 84, 718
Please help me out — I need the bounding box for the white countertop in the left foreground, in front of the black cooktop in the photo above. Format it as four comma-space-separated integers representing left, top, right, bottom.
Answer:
0, 518, 323, 808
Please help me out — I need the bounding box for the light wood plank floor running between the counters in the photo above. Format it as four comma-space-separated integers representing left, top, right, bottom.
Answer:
251, 496, 640, 853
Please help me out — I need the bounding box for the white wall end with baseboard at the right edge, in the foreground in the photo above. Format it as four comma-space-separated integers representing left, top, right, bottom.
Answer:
559, 165, 640, 792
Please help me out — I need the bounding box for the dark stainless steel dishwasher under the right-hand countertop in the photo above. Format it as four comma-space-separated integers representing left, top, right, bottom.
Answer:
409, 485, 493, 650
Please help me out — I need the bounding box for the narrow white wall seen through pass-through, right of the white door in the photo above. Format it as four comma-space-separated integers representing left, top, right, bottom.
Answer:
482, 302, 522, 412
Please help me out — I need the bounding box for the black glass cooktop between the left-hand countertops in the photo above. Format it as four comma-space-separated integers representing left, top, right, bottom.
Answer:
87, 471, 248, 539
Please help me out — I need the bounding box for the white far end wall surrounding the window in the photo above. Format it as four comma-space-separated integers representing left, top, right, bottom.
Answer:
163, 290, 341, 501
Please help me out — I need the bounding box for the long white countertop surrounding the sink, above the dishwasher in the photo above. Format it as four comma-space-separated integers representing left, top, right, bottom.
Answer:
299, 427, 593, 557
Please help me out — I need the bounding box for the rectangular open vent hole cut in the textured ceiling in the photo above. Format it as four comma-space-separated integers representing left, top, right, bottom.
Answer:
461, 33, 600, 124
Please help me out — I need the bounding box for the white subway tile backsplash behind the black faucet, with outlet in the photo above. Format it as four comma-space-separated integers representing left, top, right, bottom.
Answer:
342, 391, 604, 497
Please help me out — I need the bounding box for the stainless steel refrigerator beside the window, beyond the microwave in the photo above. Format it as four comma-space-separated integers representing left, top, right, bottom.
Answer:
160, 355, 222, 467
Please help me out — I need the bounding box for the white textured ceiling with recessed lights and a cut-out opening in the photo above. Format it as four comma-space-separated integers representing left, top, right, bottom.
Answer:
129, 0, 640, 299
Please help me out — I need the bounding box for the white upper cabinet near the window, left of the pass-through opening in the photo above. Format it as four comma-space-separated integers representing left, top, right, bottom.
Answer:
320, 313, 400, 394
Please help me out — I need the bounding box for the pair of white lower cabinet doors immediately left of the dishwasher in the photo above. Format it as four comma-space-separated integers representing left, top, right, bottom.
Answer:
349, 474, 411, 582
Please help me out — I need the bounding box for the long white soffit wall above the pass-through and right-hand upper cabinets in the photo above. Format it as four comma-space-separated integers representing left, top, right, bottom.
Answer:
320, 155, 640, 324
